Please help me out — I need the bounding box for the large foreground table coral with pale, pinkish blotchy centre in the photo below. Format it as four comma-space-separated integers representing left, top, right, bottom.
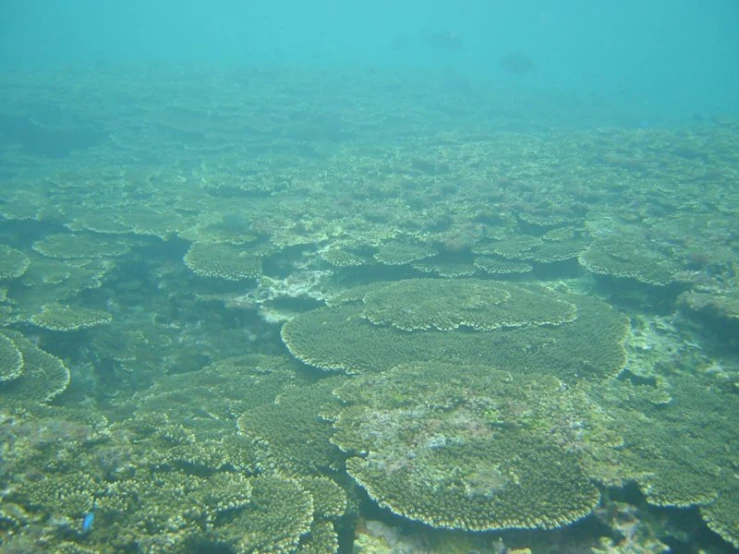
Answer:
332, 363, 599, 531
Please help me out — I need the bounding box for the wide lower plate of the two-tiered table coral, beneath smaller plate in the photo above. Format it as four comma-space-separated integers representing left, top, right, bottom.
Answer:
282, 284, 628, 381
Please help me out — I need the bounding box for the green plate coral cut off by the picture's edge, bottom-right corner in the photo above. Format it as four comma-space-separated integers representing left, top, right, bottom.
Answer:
590, 373, 739, 541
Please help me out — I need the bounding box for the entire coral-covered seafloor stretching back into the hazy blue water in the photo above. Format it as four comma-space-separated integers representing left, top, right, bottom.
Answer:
0, 64, 739, 554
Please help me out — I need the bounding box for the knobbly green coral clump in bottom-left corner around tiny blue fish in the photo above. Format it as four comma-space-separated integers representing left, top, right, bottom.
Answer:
0, 398, 326, 553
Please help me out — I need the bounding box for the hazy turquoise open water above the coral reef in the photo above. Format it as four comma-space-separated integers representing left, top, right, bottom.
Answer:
0, 0, 739, 120
